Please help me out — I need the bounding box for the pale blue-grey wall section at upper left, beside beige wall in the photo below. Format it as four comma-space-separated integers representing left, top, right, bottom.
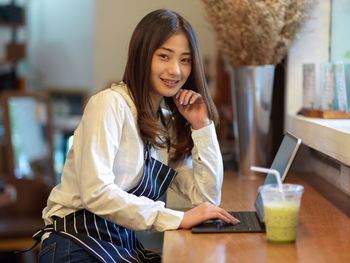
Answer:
27, 0, 95, 90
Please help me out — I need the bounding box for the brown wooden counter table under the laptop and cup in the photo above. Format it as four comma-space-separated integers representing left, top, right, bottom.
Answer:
162, 173, 350, 263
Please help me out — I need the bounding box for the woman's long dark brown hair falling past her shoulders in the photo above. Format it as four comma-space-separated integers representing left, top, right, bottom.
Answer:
123, 9, 218, 161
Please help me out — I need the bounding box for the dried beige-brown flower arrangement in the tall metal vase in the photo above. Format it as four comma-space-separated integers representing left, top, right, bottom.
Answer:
202, 0, 317, 66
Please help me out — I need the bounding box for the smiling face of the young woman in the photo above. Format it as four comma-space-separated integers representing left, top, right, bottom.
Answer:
150, 31, 192, 108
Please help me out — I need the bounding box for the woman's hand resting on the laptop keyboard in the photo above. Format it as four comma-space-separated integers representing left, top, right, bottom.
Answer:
179, 202, 239, 229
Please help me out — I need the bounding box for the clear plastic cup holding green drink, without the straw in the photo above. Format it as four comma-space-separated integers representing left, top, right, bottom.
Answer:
259, 184, 304, 243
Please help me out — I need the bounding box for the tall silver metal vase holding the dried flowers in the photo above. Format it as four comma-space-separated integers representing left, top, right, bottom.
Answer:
230, 65, 275, 179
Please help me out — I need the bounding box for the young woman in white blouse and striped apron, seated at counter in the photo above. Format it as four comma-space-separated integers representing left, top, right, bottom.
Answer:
37, 10, 237, 262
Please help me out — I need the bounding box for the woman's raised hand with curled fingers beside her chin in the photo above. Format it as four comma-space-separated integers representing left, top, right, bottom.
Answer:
173, 89, 210, 130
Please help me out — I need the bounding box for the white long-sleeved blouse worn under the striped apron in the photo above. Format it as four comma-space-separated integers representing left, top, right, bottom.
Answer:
43, 84, 223, 231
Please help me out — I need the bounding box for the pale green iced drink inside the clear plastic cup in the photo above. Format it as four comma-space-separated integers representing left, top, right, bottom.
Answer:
264, 201, 299, 243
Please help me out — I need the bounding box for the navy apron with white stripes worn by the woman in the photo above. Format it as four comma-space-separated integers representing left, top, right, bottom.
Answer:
33, 143, 177, 263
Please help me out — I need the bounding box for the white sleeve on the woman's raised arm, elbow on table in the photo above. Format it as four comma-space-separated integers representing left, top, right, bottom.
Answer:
171, 123, 223, 205
